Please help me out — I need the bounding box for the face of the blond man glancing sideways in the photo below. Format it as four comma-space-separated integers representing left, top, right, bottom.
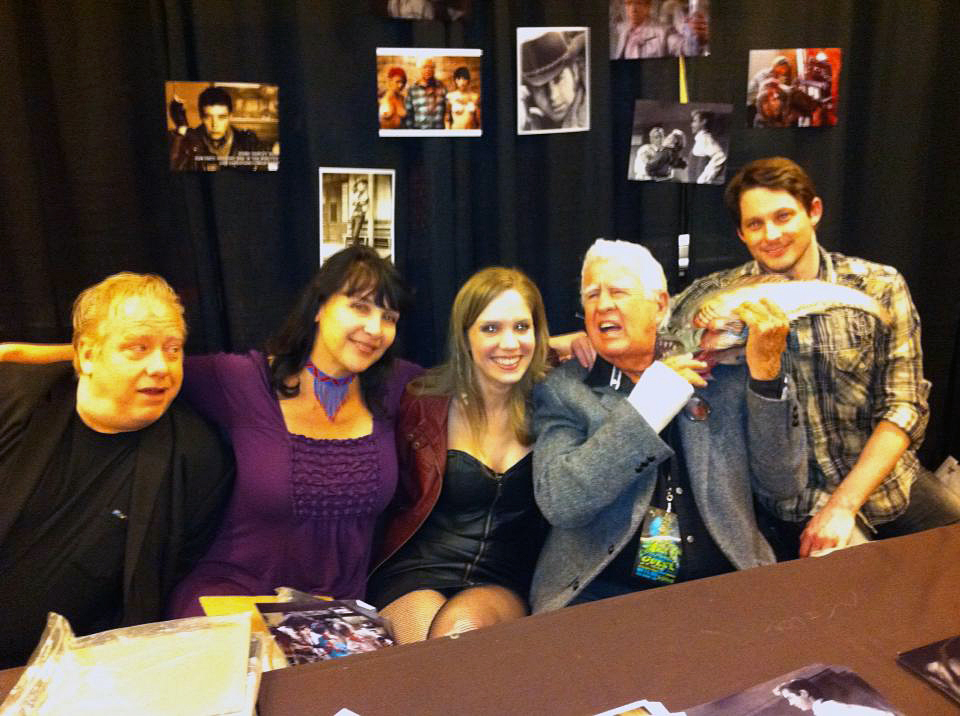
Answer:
77, 296, 184, 433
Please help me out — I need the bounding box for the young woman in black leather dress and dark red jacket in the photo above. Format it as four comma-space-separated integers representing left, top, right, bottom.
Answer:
367, 267, 549, 643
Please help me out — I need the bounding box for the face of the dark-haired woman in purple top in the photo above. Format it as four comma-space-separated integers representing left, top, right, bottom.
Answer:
310, 289, 400, 378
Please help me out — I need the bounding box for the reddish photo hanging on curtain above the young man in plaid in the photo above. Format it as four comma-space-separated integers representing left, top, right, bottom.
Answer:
747, 47, 842, 127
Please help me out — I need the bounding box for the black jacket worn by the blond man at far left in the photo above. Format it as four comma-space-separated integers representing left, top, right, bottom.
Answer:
0, 363, 233, 626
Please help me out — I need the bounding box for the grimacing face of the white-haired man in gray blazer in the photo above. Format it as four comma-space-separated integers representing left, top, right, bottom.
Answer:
581, 259, 668, 377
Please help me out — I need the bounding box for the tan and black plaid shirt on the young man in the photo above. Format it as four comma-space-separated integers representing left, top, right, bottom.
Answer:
674, 247, 930, 524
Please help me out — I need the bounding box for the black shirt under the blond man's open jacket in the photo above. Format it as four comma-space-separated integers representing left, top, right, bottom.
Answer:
0, 414, 139, 666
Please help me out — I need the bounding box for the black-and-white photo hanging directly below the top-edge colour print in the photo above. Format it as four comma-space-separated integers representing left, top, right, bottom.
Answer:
627, 99, 733, 184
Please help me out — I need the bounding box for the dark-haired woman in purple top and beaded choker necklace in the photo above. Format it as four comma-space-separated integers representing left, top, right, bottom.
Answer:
161, 246, 419, 617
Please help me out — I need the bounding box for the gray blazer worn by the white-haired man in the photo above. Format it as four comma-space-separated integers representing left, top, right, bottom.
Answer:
530, 361, 807, 612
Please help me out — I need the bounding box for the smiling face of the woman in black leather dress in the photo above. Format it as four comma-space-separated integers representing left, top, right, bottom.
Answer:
467, 289, 537, 391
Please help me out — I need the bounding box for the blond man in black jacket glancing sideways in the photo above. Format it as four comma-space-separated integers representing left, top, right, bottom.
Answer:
0, 273, 231, 667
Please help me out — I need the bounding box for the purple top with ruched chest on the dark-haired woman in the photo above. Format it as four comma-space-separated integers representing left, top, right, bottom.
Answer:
168, 351, 420, 618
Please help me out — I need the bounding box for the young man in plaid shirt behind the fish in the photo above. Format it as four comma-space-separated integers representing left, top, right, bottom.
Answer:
674, 157, 960, 558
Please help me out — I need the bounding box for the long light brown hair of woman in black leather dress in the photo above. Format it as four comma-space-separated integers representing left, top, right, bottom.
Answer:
410, 266, 550, 445
